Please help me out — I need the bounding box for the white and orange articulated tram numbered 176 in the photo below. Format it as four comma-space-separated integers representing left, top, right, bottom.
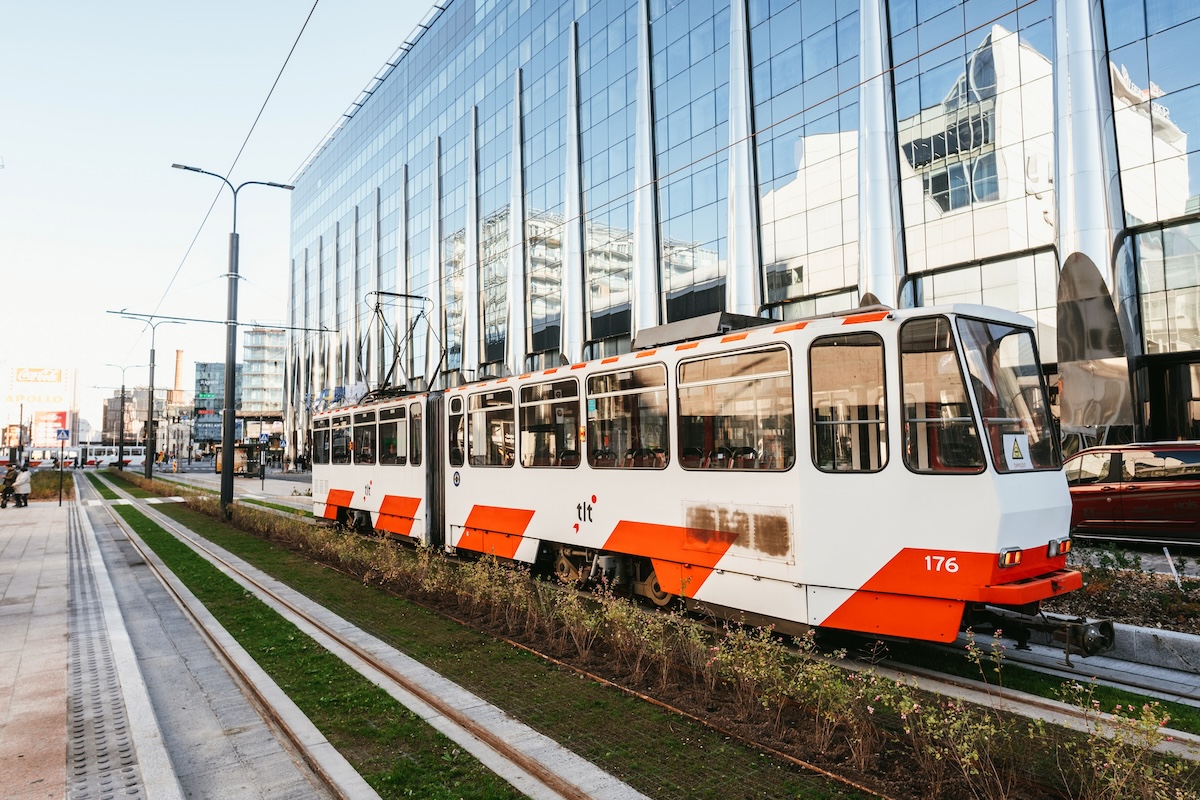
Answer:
312, 305, 1110, 651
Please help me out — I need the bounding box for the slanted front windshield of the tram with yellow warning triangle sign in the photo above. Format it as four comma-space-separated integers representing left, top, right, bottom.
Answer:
959, 318, 1062, 473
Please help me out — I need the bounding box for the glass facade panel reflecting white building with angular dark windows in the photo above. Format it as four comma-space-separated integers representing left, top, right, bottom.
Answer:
890, 0, 1055, 272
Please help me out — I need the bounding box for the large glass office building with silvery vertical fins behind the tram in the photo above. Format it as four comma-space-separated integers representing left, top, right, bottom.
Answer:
286, 0, 1200, 462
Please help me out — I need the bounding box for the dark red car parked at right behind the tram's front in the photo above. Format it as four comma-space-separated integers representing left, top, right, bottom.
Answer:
1064, 441, 1200, 545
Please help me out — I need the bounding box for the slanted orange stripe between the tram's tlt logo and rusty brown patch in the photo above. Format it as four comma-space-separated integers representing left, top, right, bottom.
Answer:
604, 519, 738, 597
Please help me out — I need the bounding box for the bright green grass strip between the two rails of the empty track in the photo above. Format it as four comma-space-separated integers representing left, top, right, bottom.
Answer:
116, 506, 521, 800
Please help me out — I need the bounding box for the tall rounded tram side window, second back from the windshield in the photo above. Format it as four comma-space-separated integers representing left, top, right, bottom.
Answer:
809, 333, 888, 473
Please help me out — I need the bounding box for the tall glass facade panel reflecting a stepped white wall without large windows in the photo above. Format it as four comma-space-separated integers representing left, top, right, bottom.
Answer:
750, 1, 859, 303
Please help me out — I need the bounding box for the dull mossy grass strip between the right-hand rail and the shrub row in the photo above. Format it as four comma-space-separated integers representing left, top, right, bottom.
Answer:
154, 506, 862, 800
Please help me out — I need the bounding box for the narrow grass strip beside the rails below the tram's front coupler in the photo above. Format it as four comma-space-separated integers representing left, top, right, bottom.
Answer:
893, 648, 1200, 735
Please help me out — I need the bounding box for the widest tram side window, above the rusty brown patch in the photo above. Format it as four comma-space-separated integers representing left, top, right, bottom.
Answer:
679, 348, 796, 471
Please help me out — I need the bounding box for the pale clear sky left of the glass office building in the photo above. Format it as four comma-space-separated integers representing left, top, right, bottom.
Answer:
0, 0, 432, 428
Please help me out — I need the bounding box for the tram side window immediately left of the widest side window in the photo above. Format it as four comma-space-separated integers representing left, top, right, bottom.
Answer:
588, 365, 667, 469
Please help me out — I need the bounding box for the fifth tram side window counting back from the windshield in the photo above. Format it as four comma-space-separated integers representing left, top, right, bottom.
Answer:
517, 378, 581, 469
